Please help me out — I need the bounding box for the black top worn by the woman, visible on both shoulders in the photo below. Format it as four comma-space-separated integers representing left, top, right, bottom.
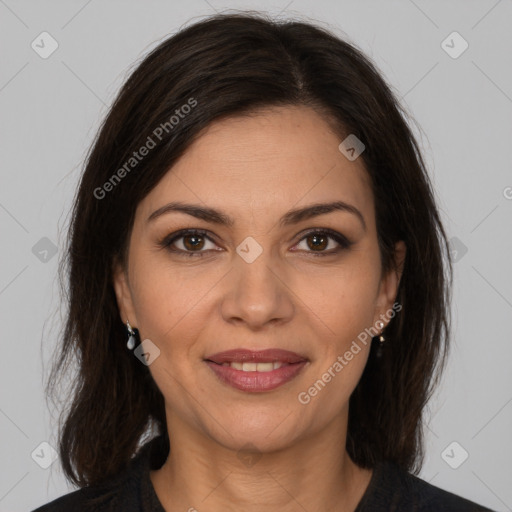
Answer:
33, 436, 493, 512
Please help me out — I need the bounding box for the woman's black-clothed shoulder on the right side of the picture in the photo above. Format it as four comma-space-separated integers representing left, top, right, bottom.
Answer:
357, 462, 493, 512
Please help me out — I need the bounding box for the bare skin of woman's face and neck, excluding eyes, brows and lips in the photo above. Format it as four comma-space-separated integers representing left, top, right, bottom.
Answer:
114, 107, 405, 512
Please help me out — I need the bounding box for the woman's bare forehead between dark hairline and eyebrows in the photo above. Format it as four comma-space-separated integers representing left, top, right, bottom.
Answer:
139, 107, 373, 226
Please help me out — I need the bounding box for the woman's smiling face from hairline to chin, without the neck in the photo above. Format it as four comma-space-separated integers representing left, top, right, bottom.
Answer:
115, 107, 404, 451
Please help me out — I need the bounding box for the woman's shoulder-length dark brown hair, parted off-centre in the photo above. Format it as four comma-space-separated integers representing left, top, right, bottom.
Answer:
48, 12, 452, 486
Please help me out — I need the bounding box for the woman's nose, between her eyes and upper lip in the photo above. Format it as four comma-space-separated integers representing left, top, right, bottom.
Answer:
221, 251, 296, 330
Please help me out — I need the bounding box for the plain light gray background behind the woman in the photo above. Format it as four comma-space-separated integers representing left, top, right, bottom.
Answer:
0, 0, 512, 512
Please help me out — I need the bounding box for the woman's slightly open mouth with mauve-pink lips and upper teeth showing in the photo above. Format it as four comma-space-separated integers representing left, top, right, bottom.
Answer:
204, 349, 309, 392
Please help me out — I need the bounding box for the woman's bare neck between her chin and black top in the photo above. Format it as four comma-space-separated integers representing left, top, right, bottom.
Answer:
150, 410, 372, 512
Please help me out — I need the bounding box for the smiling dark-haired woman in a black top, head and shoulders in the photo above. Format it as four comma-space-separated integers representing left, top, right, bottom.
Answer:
37, 10, 489, 512
